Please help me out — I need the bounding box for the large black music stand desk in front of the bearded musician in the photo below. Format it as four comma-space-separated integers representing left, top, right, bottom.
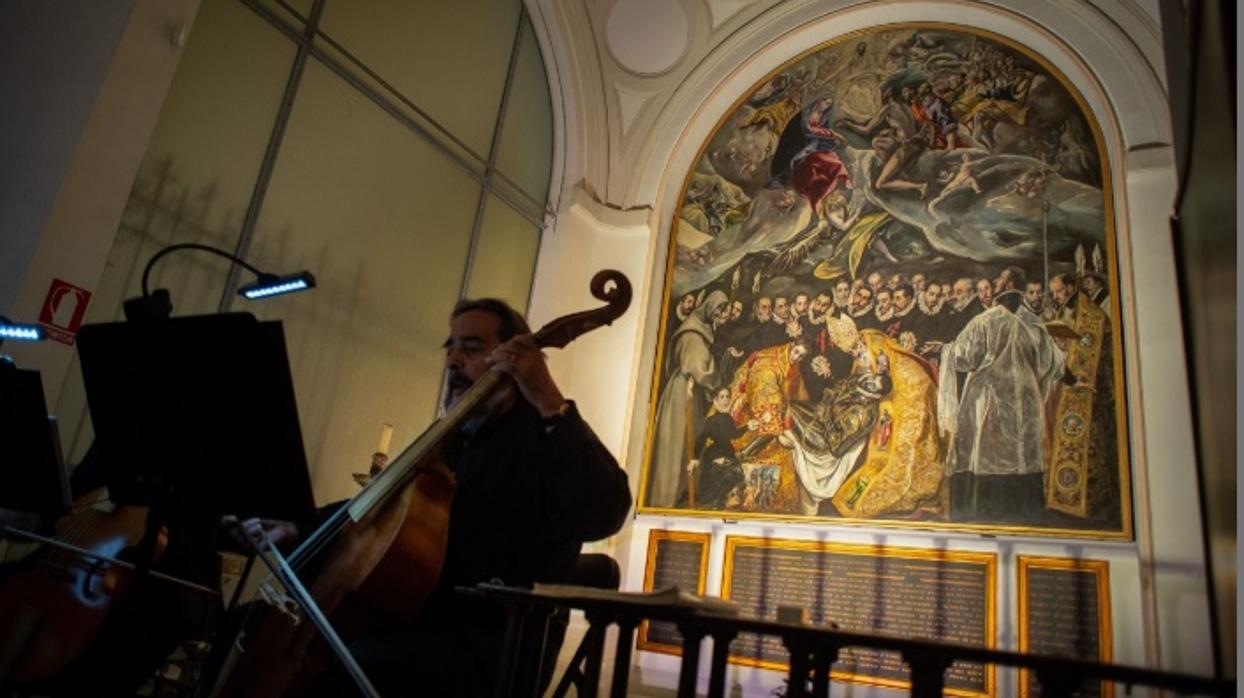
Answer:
77, 314, 315, 521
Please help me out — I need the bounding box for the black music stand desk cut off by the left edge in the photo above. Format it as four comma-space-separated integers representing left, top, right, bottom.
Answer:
0, 360, 70, 520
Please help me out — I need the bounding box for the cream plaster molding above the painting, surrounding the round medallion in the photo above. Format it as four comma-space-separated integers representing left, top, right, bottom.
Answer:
527, 0, 1171, 209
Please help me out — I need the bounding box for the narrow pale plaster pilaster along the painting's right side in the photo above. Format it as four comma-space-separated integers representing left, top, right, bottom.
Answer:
1123, 148, 1213, 673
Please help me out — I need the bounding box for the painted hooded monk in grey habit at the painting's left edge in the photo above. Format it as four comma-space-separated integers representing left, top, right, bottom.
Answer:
647, 291, 730, 508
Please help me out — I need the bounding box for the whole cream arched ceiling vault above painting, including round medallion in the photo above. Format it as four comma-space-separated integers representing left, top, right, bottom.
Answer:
527, 0, 1171, 212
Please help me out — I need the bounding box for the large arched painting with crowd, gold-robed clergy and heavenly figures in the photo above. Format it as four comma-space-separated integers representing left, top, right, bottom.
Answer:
642, 25, 1131, 539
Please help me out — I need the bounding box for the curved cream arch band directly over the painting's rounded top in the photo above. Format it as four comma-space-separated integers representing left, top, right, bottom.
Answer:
631, 0, 1171, 209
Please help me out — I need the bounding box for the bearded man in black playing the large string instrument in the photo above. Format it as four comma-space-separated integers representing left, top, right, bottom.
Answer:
228, 299, 631, 696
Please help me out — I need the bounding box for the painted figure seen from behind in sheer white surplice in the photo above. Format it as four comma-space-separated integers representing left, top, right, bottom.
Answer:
938, 286, 1066, 524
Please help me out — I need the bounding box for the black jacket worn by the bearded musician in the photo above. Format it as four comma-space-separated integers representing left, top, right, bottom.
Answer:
425, 399, 631, 615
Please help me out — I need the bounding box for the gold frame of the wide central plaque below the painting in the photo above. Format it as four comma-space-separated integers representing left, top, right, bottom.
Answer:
722, 536, 998, 697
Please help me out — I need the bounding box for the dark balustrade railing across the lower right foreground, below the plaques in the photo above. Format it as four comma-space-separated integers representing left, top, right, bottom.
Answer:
459, 585, 1235, 698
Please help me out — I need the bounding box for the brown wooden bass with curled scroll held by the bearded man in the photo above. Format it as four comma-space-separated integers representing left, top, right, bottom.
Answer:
213, 270, 631, 697
